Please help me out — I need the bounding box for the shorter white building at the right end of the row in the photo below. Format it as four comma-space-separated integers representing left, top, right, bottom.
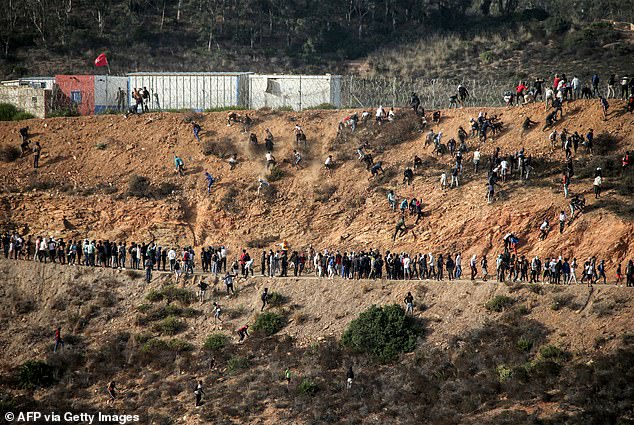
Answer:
249, 74, 341, 111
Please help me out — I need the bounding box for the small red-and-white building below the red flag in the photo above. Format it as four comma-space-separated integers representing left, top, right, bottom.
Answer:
55, 75, 128, 115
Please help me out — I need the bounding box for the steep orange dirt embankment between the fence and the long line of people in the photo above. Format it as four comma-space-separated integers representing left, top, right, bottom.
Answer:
0, 100, 634, 268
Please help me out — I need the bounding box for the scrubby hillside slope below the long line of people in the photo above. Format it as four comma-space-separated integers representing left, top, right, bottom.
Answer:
0, 260, 634, 424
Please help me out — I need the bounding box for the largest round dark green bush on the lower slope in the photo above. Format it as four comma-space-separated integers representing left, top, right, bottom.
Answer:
341, 304, 421, 362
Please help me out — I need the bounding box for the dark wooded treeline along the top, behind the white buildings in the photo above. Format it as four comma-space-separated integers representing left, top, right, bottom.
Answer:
0, 0, 634, 77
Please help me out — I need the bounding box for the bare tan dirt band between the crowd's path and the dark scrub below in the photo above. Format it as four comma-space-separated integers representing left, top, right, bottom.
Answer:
0, 260, 634, 367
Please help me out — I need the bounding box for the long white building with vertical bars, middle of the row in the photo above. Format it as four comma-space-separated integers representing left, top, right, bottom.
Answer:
128, 72, 249, 111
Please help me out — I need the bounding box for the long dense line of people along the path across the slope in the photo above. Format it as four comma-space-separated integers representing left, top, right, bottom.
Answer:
1, 234, 634, 286
